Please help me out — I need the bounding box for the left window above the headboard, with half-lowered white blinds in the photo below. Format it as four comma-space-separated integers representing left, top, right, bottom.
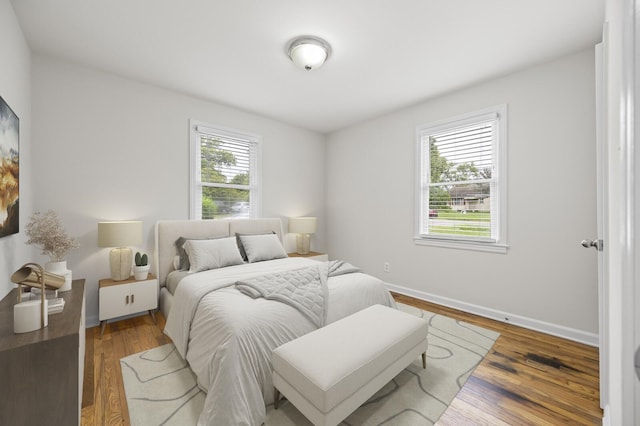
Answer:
190, 120, 261, 219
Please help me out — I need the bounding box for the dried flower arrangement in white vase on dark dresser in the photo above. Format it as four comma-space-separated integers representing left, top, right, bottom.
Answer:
25, 210, 80, 262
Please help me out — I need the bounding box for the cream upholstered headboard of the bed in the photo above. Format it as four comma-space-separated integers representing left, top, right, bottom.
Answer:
154, 218, 283, 286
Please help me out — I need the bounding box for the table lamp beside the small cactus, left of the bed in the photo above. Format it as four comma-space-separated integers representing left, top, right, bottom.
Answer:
98, 220, 142, 281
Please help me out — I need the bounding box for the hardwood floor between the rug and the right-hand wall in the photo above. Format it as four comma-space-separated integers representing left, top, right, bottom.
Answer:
394, 294, 602, 425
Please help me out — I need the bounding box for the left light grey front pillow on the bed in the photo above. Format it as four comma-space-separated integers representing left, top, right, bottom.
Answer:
183, 237, 244, 272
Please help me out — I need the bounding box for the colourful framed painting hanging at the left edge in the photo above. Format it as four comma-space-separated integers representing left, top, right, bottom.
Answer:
0, 97, 20, 237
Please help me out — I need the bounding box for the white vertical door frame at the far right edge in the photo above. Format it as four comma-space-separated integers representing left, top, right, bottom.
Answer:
603, 0, 640, 425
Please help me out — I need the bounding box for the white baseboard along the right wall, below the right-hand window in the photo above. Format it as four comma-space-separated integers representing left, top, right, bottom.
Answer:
385, 283, 599, 347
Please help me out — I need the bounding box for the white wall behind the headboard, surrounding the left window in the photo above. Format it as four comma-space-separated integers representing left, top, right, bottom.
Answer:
32, 55, 326, 325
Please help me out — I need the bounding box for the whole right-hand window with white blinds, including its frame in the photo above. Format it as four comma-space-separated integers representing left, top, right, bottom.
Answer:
414, 105, 507, 253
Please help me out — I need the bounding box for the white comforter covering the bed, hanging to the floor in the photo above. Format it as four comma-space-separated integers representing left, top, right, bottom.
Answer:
165, 258, 394, 426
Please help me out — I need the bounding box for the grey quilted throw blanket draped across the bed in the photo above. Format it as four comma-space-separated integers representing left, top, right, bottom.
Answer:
236, 260, 360, 327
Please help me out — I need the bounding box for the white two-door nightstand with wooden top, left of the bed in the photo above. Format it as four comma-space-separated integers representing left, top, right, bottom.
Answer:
99, 274, 158, 336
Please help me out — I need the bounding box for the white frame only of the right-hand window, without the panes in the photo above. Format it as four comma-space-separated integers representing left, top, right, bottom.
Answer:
413, 104, 508, 254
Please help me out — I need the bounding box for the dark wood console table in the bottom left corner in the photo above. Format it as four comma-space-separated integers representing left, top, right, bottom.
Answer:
0, 279, 85, 425
